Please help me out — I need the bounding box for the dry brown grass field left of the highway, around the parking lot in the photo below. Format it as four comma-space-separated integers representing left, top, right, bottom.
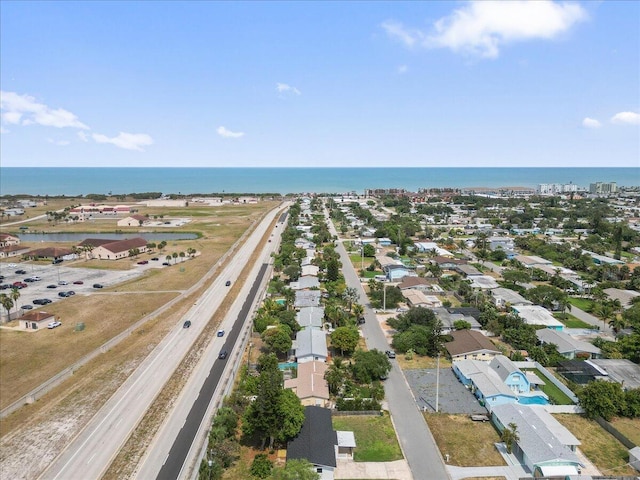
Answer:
0, 202, 275, 478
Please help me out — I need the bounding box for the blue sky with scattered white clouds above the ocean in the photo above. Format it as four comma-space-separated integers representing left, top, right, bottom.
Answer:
0, 0, 640, 167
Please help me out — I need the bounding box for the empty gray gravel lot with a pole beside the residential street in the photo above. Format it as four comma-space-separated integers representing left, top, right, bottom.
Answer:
404, 368, 487, 415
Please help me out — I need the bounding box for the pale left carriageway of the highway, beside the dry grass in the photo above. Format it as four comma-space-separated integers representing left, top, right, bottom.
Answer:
40, 205, 277, 480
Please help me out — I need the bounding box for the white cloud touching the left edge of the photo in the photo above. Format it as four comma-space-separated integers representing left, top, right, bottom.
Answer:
0, 91, 89, 130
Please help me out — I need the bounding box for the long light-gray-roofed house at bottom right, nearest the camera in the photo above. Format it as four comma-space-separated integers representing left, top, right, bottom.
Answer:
491, 404, 584, 478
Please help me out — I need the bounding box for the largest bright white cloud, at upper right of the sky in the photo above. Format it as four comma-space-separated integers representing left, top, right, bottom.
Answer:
382, 0, 587, 58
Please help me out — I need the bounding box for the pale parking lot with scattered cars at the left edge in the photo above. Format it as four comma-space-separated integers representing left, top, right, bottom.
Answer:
0, 262, 151, 317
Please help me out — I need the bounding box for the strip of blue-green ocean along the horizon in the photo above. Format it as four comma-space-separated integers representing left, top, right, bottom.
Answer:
0, 167, 640, 196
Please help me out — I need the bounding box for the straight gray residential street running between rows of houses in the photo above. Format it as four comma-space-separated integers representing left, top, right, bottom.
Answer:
329, 215, 450, 480
